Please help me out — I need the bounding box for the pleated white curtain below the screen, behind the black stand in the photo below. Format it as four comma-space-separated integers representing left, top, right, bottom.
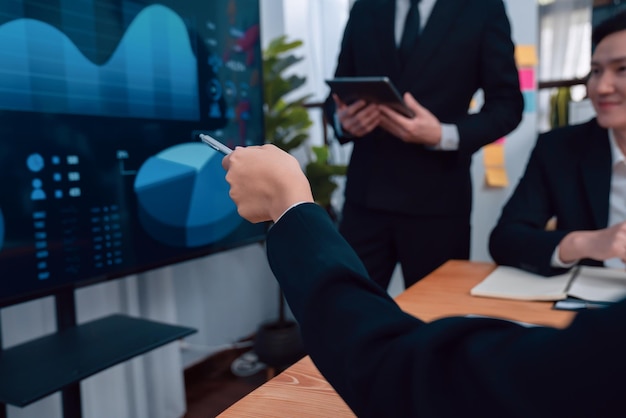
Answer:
1, 270, 185, 418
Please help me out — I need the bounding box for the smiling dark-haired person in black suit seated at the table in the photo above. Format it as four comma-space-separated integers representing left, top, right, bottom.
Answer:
489, 11, 626, 276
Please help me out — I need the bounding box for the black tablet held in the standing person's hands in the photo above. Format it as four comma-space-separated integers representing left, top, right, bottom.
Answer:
326, 77, 415, 118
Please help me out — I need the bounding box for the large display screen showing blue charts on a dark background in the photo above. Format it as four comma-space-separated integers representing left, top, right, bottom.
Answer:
0, 0, 266, 306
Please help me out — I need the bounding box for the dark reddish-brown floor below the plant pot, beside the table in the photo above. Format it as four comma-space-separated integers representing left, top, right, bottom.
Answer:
184, 348, 267, 418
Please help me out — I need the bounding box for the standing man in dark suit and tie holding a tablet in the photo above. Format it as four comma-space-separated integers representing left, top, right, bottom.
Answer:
325, 0, 524, 289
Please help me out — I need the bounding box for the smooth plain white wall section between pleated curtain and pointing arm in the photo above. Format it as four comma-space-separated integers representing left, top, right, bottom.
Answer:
174, 244, 279, 364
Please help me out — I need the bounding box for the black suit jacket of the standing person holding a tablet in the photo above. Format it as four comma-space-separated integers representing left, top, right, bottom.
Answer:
326, 0, 524, 216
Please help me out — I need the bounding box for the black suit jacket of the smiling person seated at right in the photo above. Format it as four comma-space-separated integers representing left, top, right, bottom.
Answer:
489, 119, 612, 275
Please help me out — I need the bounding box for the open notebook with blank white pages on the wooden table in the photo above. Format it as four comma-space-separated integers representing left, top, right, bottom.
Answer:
470, 266, 626, 302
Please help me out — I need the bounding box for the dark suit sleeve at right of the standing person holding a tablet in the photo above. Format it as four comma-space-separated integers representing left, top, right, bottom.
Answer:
450, 0, 524, 153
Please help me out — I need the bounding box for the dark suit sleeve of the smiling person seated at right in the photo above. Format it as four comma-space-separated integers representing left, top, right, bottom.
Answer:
489, 135, 569, 276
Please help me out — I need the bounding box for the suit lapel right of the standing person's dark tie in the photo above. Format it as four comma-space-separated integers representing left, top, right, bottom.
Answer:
396, 0, 468, 85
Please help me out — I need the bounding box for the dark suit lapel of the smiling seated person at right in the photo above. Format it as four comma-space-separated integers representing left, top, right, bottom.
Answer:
580, 124, 613, 229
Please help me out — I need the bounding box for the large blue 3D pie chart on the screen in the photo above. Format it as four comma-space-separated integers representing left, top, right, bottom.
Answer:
134, 143, 243, 247
